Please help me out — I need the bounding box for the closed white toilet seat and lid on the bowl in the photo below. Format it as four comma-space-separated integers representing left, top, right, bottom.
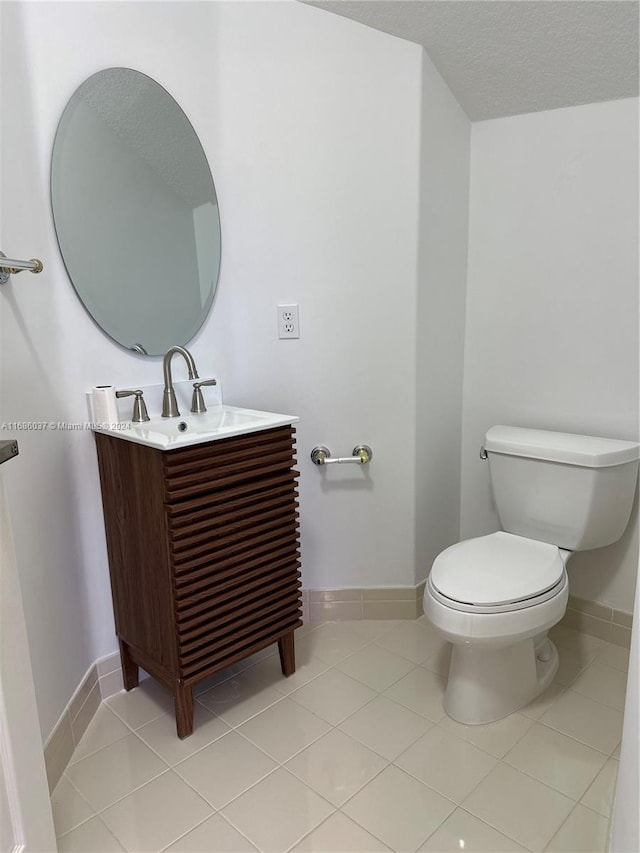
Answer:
428, 531, 566, 613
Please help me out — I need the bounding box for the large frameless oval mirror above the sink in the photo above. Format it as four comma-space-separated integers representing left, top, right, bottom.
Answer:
51, 68, 220, 355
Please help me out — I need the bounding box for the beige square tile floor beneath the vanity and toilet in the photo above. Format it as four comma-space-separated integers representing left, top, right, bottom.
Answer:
52, 617, 628, 853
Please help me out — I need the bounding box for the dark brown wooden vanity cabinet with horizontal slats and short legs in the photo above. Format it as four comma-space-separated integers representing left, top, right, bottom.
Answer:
95, 426, 302, 738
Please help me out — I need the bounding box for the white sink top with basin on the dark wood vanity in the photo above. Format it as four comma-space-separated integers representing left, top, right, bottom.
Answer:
96, 405, 299, 450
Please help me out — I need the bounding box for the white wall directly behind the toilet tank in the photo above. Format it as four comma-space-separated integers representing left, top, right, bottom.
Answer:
461, 99, 639, 612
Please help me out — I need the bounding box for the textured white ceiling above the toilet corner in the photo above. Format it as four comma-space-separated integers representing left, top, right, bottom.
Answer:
303, 0, 639, 120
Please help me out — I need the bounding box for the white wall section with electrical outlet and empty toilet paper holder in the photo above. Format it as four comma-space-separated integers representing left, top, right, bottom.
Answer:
202, 3, 421, 589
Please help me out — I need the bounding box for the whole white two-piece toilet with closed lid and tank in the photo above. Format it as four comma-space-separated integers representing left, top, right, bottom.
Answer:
424, 426, 640, 725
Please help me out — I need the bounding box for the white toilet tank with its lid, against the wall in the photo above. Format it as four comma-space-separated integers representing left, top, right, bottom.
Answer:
484, 426, 640, 551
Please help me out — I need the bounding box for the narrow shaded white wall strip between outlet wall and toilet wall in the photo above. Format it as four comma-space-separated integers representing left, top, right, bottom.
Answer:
415, 53, 471, 583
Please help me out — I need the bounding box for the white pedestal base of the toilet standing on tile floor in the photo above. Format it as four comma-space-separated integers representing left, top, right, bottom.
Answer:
444, 636, 559, 726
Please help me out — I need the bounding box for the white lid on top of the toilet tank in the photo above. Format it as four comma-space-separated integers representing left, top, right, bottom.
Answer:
484, 425, 640, 468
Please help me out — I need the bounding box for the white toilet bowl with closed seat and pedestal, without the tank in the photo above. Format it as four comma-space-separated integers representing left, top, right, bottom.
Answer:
424, 532, 570, 725
